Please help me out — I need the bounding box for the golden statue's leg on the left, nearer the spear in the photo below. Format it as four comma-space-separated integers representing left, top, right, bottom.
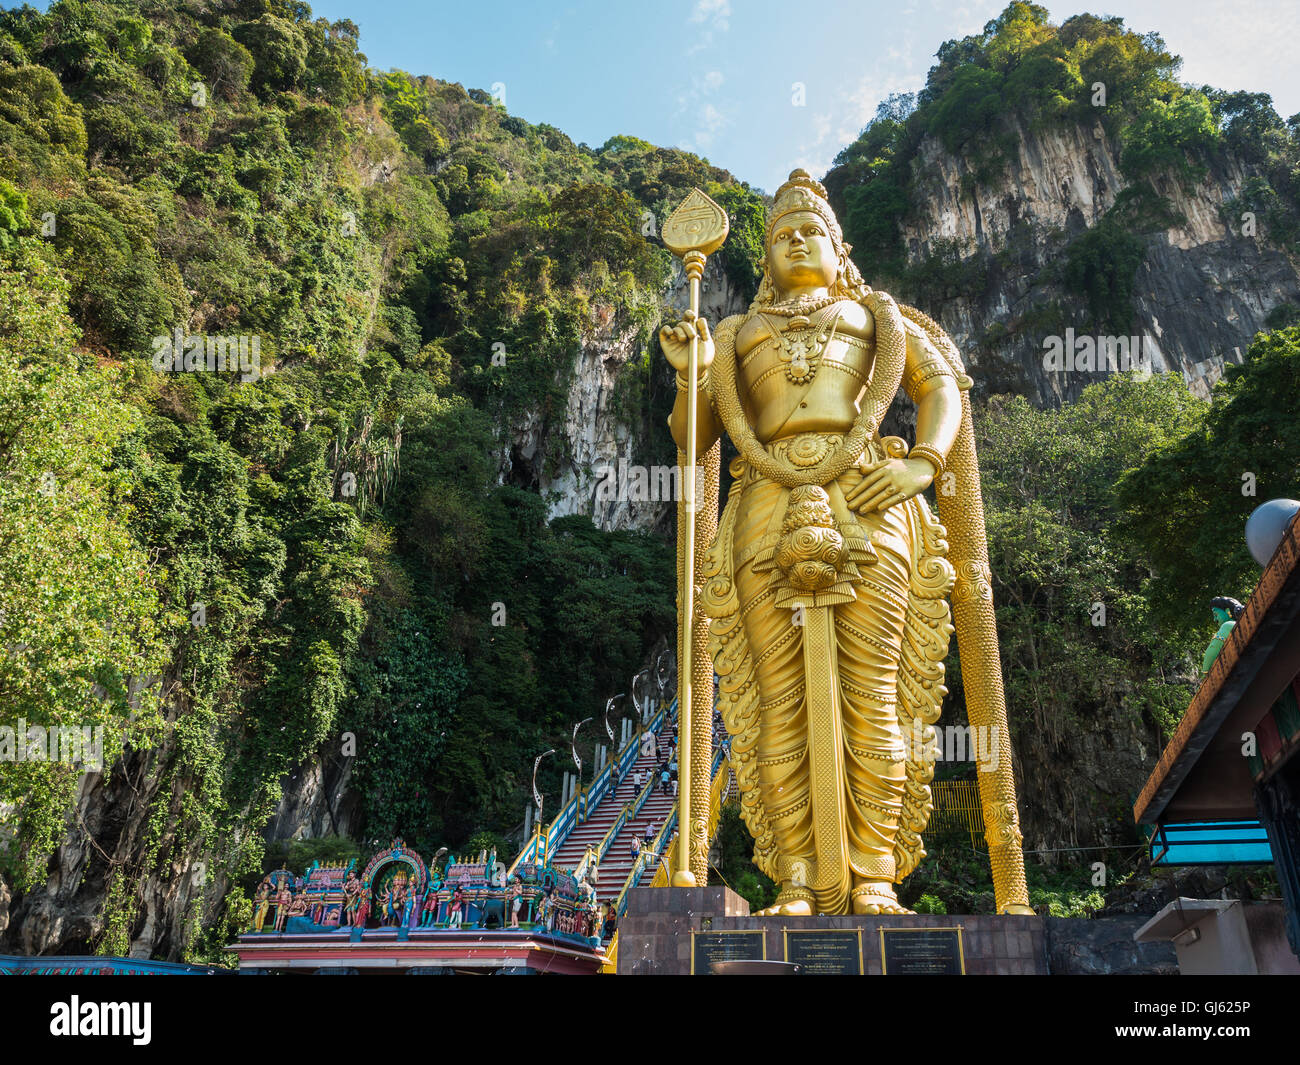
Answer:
736, 564, 816, 914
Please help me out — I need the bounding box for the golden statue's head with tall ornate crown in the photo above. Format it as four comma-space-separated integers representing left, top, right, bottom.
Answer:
751, 170, 866, 309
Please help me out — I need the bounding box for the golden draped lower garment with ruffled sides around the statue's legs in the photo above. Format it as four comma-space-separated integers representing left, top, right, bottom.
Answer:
701, 304, 953, 913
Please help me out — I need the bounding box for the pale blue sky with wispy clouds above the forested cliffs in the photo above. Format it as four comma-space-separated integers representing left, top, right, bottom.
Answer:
299, 0, 1300, 191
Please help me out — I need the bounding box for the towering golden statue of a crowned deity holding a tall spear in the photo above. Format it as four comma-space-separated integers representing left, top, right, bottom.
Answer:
660, 170, 1032, 915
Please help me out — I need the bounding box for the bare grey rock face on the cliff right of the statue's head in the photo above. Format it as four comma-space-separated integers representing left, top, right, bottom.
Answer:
894, 113, 1300, 404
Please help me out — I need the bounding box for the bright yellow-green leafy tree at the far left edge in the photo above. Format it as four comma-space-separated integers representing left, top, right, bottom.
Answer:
0, 239, 164, 887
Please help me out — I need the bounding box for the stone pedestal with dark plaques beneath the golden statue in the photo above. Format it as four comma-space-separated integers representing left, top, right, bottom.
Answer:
619, 887, 1048, 975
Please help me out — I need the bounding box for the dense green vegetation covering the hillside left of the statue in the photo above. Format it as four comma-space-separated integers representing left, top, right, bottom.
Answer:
0, 0, 762, 953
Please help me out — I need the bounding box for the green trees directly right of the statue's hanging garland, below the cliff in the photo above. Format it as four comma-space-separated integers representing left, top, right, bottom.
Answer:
972, 375, 1201, 843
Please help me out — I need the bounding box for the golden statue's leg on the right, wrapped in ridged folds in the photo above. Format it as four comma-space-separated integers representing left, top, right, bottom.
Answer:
836, 512, 910, 913
